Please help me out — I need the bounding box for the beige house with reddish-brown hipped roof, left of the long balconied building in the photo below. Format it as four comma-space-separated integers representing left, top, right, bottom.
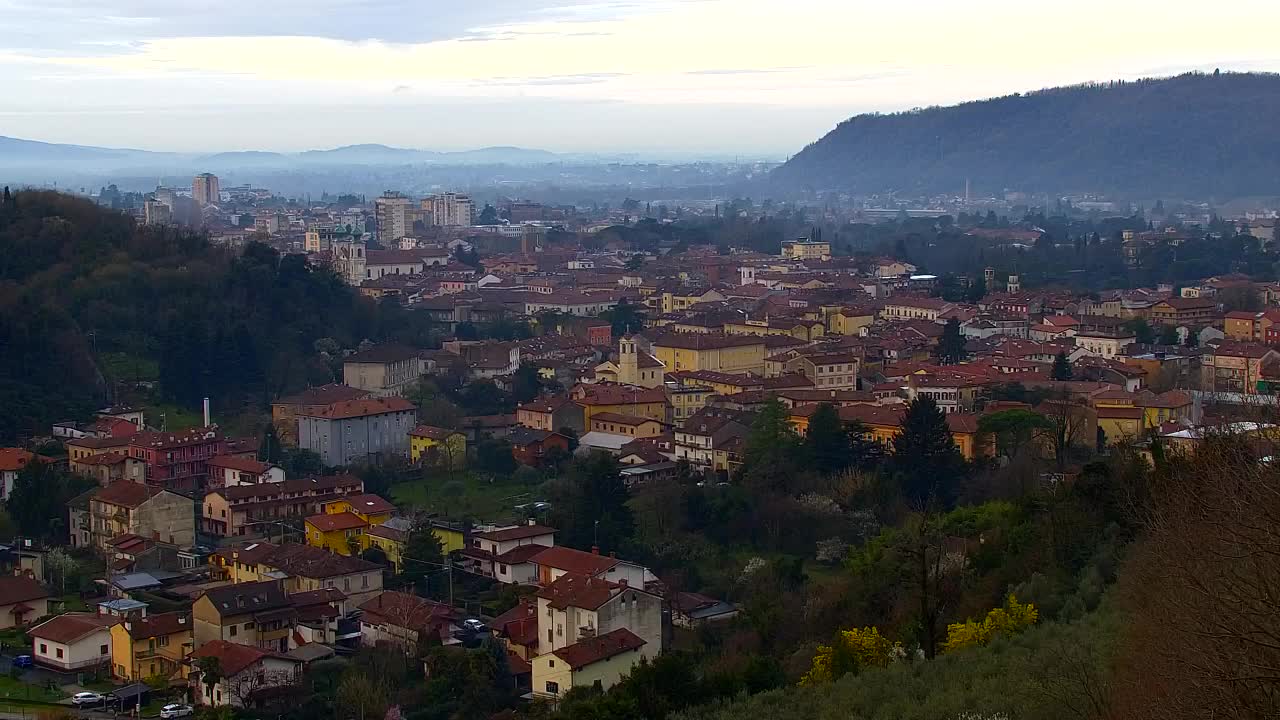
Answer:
90, 483, 196, 553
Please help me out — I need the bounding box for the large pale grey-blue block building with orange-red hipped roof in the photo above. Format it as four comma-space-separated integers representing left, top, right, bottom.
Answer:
298, 397, 417, 468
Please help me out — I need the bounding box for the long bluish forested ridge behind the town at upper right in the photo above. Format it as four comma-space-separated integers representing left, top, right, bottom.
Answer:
773, 73, 1280, 200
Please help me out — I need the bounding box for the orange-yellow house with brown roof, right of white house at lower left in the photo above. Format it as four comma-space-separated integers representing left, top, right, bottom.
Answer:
111, 612, 195, 683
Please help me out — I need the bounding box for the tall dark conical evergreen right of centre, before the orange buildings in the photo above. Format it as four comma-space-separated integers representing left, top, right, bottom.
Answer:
892, 396, 964, 510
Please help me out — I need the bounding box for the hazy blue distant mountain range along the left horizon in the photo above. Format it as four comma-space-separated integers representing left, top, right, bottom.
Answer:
0, 136, 588, 173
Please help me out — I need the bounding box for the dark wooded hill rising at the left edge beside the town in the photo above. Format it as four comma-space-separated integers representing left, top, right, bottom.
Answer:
0, 191, 426, 445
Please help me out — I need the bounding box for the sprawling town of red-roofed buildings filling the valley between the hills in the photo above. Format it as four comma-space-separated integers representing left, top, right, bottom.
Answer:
0, 169, 1280, 717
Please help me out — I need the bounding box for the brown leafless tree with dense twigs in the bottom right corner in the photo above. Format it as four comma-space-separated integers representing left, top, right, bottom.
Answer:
1114, 436, 1280, 720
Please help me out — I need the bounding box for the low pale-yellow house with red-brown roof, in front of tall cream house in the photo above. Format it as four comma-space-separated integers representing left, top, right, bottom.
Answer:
532, 629, 644, 698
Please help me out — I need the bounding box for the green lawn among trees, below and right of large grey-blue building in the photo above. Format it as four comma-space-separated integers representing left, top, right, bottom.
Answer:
390, 471, 543, 521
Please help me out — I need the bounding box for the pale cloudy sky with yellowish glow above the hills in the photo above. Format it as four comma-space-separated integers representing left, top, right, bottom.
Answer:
0, 0, 1280, 158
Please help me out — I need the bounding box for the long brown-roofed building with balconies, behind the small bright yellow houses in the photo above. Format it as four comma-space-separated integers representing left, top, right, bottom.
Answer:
200, 475, 365, 537
